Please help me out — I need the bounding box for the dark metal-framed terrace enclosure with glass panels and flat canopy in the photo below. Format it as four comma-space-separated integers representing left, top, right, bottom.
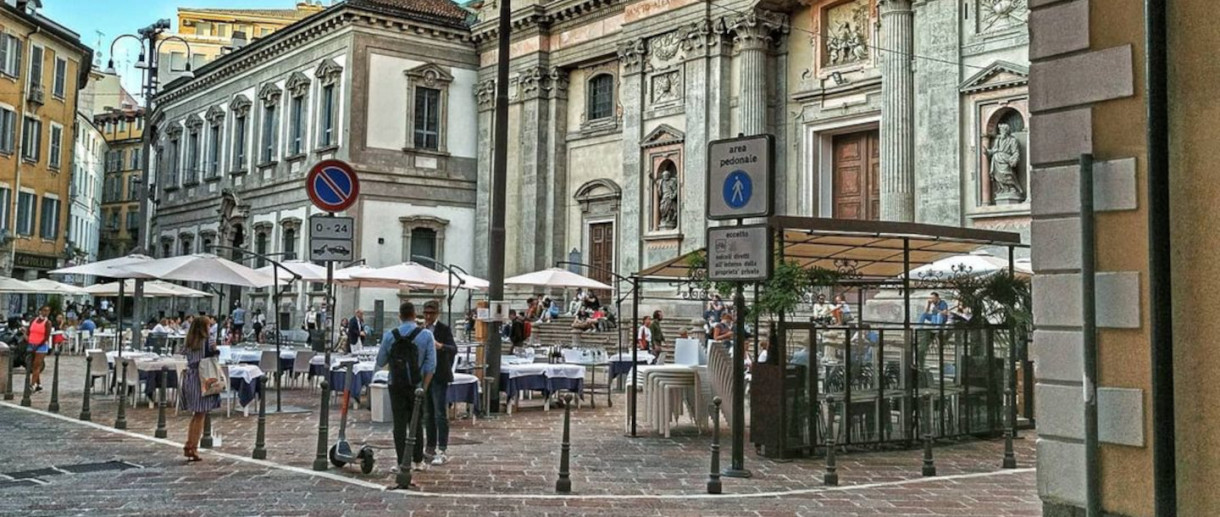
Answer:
628, 216, 1032, 458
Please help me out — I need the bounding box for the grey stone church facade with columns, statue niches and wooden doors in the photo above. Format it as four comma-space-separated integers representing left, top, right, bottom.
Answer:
473, 0, 1030, 290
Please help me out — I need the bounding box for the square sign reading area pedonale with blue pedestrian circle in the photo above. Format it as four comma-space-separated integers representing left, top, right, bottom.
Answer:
708, 134, 775, 219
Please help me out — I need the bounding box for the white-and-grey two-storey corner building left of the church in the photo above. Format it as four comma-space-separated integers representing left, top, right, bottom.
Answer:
150, 0, 477, 327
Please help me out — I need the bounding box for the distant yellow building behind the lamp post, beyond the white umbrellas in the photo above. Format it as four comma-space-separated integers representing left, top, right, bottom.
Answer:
93, 109, 144, 259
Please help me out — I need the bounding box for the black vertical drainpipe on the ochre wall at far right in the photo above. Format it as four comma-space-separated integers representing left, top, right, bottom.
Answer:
1144, 0, 1177, 516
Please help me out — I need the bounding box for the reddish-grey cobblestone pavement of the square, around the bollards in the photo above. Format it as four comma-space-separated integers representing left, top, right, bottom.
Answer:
0, 356, 1041, 516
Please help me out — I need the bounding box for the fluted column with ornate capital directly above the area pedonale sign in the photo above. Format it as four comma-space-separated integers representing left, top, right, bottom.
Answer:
727, 11, 787, 135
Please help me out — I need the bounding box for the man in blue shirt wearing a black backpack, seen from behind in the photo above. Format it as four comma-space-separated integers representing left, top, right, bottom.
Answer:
376, 301, 437, 475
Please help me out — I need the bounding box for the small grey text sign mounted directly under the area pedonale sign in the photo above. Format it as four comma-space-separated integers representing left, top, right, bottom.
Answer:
708, 224, 772, 282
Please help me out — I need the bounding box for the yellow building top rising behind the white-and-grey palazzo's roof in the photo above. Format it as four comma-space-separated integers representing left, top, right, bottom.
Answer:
157, 1, 325, 84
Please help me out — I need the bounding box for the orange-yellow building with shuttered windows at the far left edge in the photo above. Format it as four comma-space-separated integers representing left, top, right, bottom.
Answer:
0, 2, 93, 278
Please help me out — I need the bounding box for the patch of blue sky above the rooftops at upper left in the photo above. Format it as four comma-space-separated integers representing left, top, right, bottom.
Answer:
41, 0, 305, 99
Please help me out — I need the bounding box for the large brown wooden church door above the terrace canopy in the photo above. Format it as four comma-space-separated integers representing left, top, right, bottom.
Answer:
832, 129, 881, 219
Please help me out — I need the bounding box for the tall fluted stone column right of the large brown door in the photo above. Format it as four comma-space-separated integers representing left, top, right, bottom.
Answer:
881, 0, 915, 222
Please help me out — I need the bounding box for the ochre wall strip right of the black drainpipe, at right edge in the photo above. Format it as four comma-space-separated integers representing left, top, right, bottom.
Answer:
1169, 0, 1220, 516
